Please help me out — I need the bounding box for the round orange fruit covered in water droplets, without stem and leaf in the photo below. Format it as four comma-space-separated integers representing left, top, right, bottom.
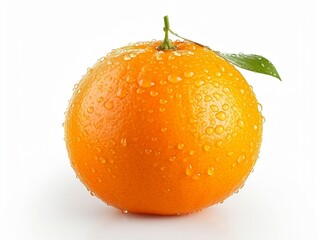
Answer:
65, 41, 263, 215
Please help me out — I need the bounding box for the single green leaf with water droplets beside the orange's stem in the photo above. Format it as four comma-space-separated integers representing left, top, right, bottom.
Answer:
215, 51, 281, 81
